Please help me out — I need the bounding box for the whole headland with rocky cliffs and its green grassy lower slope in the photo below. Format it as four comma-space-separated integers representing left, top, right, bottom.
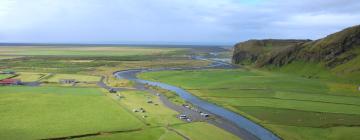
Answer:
233, 25, 360, 82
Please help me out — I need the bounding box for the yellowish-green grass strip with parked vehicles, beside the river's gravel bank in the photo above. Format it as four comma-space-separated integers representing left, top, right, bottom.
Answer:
82, 91, 239, 140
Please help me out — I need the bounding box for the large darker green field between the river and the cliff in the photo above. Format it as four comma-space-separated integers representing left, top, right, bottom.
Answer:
140, 70, 360, 139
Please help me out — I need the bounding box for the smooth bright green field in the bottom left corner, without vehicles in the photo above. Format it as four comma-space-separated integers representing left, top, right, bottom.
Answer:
0, 87, 144, 139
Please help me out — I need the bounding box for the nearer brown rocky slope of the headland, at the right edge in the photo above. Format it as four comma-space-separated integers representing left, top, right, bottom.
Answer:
297, 25, 360, 67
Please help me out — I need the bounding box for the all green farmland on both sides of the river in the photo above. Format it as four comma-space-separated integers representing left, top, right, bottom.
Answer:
0, 44, 360, 140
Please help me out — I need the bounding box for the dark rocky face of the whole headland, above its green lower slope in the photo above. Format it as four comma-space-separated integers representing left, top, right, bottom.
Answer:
233, 25, 360, 67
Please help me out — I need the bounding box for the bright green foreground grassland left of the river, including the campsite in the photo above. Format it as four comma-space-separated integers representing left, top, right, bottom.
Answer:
0, 86, 242, 140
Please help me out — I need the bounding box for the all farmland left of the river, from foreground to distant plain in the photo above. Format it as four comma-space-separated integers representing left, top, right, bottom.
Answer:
0, 47, 239, 140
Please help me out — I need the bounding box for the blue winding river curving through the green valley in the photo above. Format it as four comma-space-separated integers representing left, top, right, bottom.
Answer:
115, 57, 280, 140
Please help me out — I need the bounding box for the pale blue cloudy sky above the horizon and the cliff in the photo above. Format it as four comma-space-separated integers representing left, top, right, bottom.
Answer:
0, 0, 360, 45
